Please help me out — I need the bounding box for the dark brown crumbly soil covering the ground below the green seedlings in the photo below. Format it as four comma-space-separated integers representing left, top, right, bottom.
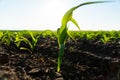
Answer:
0, 37, 120, 80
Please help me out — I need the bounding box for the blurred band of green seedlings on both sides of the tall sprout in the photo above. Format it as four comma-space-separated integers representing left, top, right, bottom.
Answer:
0, 30, 120, 46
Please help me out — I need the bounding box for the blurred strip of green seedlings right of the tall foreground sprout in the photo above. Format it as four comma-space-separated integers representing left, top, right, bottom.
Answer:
71, 31, 120, 44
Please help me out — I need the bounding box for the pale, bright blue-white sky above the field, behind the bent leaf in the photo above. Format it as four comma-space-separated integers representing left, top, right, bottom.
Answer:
0, 0, 120, 30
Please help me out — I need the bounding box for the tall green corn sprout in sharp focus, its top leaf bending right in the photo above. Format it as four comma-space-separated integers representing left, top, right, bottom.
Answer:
57, 1, 107, 72
